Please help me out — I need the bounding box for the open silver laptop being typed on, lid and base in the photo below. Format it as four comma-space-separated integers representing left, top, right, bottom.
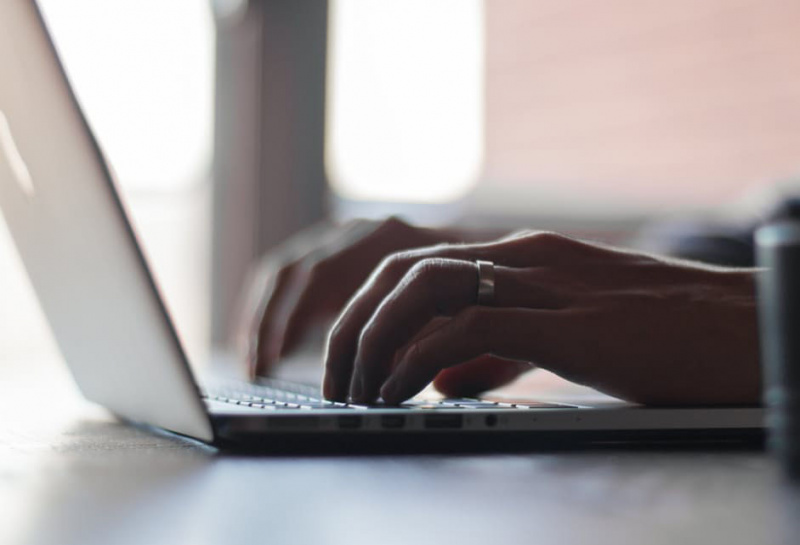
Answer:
0, 0, 764, 451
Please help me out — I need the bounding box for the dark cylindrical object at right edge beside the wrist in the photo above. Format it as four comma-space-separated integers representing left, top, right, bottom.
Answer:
756, 220, 800, 479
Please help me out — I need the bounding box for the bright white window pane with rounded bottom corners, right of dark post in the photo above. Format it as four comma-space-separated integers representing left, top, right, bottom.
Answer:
326, 0, 484, 203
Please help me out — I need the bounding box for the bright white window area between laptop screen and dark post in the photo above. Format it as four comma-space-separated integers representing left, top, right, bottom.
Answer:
40, 0, 214, 191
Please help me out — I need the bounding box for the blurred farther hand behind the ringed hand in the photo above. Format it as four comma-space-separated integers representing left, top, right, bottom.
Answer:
238, 218, 444, 376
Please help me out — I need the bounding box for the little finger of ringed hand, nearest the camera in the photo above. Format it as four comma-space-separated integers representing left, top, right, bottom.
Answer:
381, 307, 569, 403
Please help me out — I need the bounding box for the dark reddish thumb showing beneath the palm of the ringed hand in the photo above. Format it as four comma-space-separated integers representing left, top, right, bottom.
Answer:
433, 355, 534, 397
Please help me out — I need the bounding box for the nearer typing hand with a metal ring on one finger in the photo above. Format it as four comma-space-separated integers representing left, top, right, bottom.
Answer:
323, 233, 760, 404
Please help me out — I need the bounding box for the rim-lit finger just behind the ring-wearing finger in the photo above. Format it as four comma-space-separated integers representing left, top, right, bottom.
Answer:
323, 233, 582, 401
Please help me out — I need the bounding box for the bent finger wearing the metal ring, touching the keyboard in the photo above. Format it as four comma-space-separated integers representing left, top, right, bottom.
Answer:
350, 259, 565, 402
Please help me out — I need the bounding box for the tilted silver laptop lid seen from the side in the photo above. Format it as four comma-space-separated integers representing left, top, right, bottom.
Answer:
0, 0, 213, 440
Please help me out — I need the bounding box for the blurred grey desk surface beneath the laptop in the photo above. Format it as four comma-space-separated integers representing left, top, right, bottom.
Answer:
0, 354, 800, 545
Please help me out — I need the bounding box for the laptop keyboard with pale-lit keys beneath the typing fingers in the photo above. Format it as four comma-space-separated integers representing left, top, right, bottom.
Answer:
201, 379, 570, 411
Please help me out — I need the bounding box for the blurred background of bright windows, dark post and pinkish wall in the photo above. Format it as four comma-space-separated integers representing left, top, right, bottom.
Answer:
0, 0, 800, 370
